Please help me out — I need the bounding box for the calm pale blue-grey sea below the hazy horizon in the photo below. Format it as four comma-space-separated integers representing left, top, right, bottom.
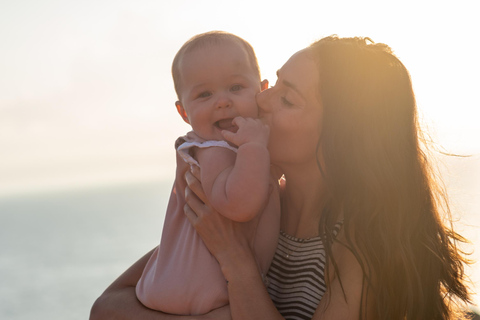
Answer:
0, 156, 480, 320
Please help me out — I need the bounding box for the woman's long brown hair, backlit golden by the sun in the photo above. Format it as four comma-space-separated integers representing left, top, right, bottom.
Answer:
309, 36, 470, 320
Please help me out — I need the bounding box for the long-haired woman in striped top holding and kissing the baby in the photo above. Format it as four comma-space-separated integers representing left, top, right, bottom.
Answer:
92, 37, 469, 319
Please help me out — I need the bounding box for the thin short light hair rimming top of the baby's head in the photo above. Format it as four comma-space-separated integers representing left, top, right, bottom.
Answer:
172, 31, 261, 99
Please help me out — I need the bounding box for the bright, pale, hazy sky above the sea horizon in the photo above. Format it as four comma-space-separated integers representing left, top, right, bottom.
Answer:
0, 0, 480, 196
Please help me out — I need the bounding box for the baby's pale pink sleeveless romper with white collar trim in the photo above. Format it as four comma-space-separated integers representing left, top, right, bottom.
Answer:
136, 132, 280, 315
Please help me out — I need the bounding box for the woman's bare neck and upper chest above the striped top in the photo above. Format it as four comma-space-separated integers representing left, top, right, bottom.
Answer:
281, 169, 325, 238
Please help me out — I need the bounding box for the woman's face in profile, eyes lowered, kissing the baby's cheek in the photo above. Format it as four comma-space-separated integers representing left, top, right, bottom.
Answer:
257, 49, 322, 167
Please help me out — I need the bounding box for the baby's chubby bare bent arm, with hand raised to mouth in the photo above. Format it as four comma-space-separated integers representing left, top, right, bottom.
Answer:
197, 117, 270, 222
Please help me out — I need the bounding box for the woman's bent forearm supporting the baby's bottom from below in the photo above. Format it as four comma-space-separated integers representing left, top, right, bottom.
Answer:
90, 250, 230, 320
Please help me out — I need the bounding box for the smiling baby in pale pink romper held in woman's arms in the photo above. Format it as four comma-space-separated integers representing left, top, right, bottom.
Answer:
136, 31, 280, 315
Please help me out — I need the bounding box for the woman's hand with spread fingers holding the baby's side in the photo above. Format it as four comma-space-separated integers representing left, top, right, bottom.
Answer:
184, 167, 259, 280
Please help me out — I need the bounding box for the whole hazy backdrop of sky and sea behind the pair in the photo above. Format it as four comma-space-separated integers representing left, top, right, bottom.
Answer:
0, 0, 480, 319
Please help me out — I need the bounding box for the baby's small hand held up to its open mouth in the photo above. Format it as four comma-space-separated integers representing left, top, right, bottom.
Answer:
222, 117, 270, 147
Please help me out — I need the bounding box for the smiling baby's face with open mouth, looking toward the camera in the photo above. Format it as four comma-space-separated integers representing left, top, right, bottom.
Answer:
179, 43, 260, 140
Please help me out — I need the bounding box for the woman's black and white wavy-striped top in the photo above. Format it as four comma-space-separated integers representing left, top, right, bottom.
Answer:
267, 224, 340, 320
